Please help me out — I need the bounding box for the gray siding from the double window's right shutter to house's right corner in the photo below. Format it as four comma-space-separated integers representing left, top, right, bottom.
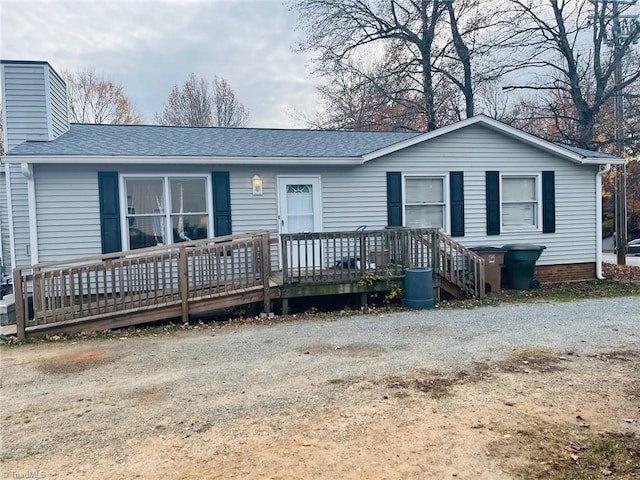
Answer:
224, 126, 597, 265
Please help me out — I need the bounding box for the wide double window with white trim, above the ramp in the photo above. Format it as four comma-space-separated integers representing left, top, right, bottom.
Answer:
123, 176, 210, 250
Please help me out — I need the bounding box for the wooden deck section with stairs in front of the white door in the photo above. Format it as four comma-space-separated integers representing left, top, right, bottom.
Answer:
280, 228, 485, 313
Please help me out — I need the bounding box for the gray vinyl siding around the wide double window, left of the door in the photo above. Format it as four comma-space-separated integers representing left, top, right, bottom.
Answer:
33, 165, 278, 262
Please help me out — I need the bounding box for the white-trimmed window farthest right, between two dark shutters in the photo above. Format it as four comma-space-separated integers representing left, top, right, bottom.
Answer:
500, 175, 540, 231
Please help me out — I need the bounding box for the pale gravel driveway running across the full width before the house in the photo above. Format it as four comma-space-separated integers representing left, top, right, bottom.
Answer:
2, 297, 640, 412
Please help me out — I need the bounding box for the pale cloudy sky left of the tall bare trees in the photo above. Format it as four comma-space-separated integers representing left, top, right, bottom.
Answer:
0, 0, 318, 128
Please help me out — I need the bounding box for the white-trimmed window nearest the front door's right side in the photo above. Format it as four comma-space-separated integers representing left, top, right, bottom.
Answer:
404, 177, 446, 230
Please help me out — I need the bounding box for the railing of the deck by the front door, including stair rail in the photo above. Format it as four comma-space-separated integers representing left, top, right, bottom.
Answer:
281, 228, 485, 298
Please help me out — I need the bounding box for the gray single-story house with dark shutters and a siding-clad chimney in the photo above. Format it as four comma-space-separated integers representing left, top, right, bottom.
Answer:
0, 61, 622, 281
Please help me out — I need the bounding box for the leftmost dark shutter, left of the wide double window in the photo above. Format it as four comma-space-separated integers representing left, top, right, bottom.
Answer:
98, 172, 122, 253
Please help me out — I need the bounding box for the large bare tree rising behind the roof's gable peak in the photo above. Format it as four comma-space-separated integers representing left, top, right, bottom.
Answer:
292, 0, 506, 130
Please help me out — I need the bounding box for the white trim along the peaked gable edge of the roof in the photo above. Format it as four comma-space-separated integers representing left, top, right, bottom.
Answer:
363, 115, 624, 165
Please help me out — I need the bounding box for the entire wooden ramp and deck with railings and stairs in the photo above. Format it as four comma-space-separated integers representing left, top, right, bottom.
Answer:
13, 229, 484, 338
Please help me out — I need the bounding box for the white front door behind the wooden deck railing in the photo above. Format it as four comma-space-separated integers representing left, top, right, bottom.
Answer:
278, 176, 322, 268
